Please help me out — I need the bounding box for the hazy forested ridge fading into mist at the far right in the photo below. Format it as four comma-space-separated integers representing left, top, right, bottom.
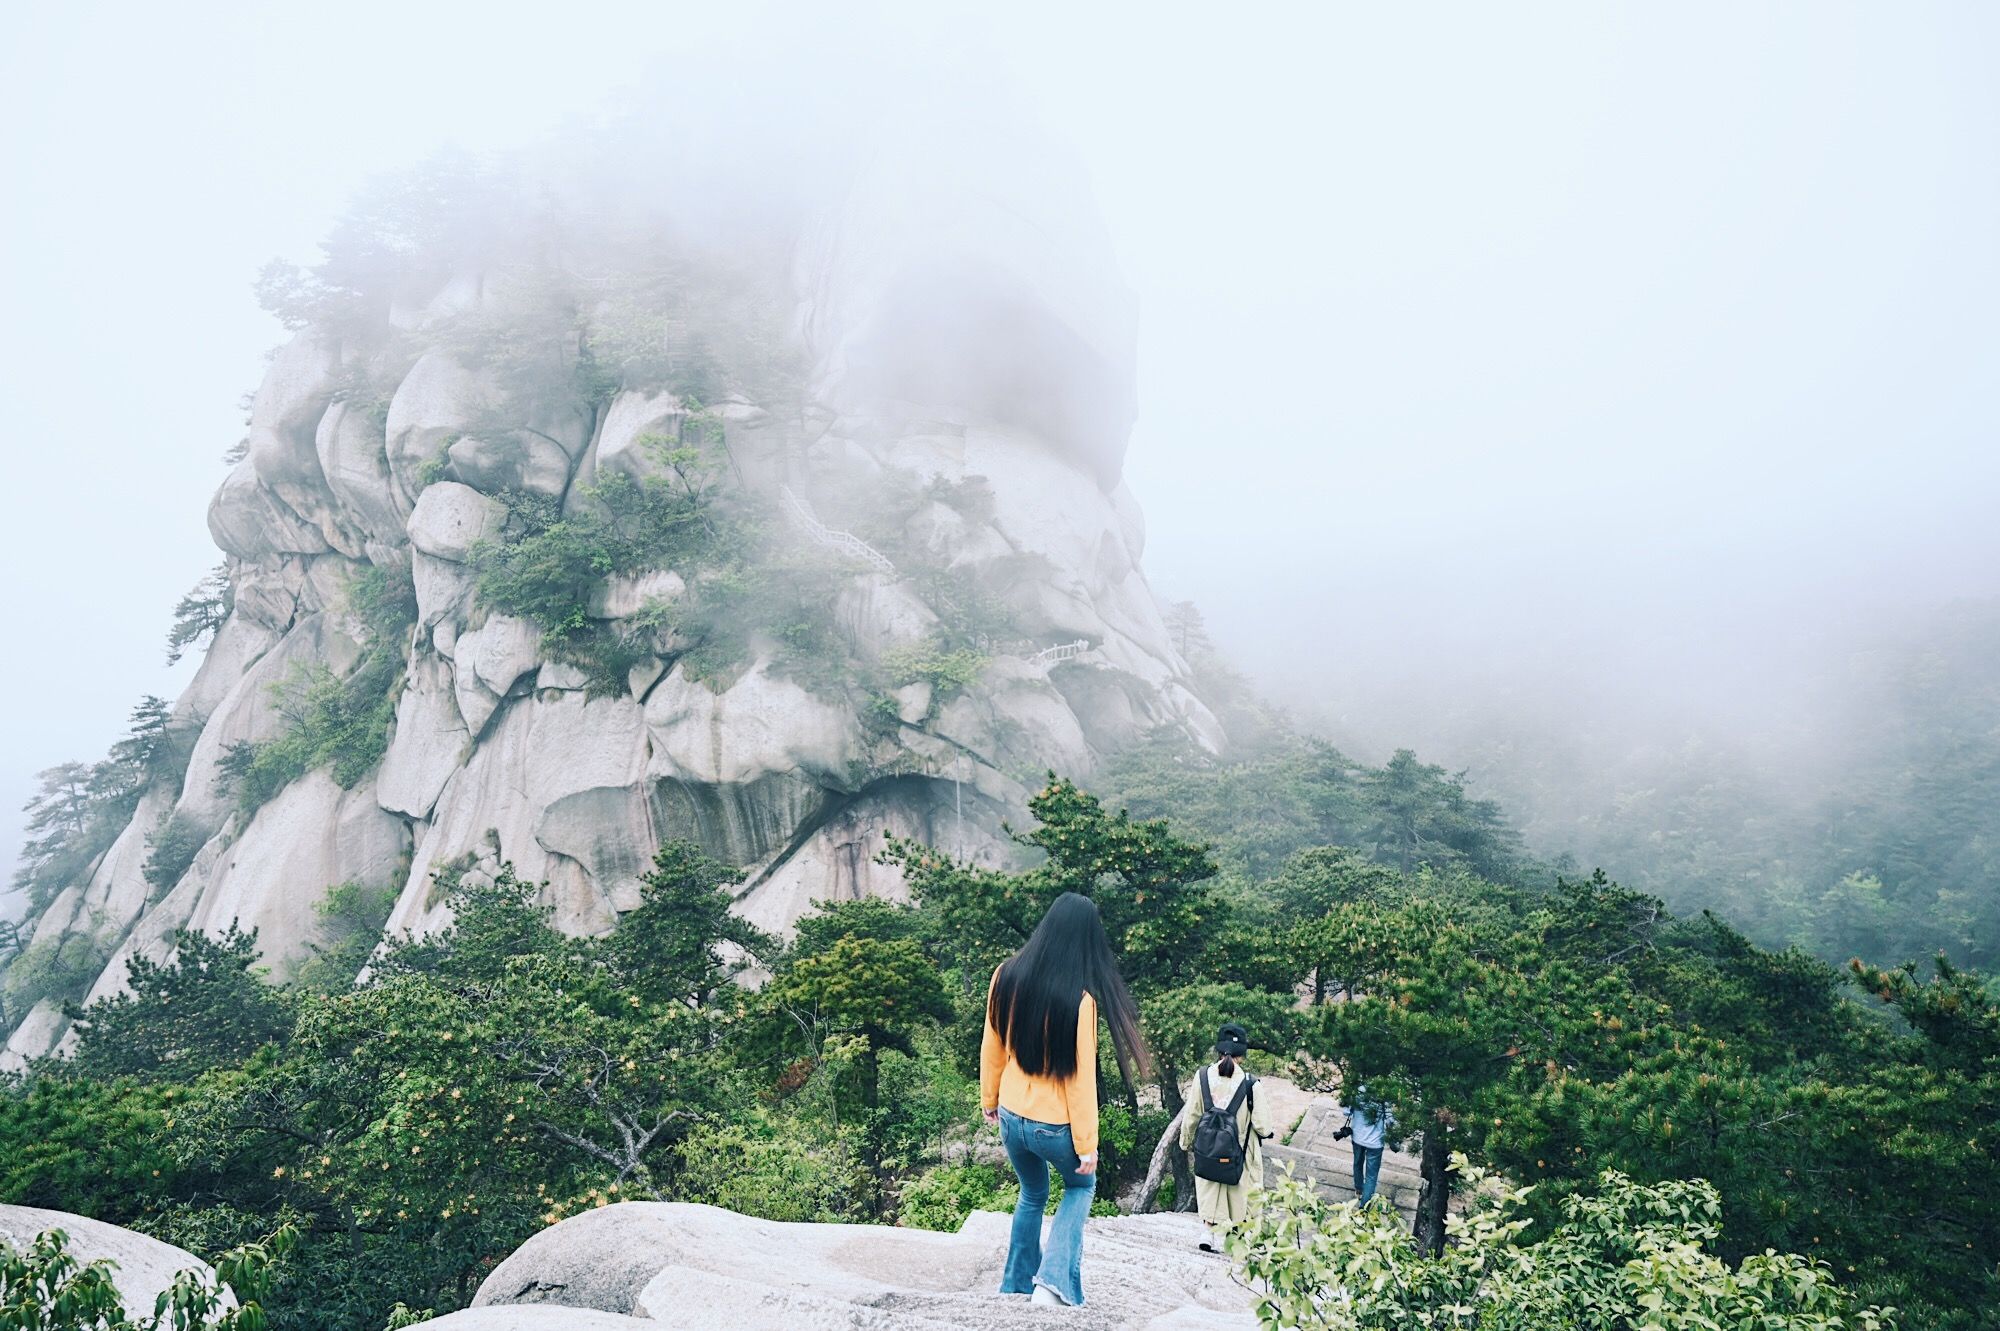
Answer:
1312, 600, 2000, 969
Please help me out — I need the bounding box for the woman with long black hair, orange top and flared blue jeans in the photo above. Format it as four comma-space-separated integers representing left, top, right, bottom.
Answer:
980, 891, 1146, 1307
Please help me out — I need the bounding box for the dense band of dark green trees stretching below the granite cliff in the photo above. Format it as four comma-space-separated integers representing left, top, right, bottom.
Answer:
11, 747, 2000, 1331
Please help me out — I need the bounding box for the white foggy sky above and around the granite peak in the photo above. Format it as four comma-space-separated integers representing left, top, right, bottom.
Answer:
0, 2, 2000, 911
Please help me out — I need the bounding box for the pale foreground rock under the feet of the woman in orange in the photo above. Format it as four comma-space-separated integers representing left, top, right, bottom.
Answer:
466, 1203, 1256, 1331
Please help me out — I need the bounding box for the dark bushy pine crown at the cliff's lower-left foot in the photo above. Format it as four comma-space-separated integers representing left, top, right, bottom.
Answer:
68, 923, 290, 1079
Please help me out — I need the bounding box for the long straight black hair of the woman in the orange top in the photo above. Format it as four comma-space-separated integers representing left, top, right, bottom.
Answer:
986, 891, 1150, 1083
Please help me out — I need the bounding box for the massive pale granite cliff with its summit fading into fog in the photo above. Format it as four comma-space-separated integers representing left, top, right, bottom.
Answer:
8, 119, 1220, 1061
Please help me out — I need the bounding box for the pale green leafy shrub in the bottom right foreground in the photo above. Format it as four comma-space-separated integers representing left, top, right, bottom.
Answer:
1226, 1157, 1896, 1331
